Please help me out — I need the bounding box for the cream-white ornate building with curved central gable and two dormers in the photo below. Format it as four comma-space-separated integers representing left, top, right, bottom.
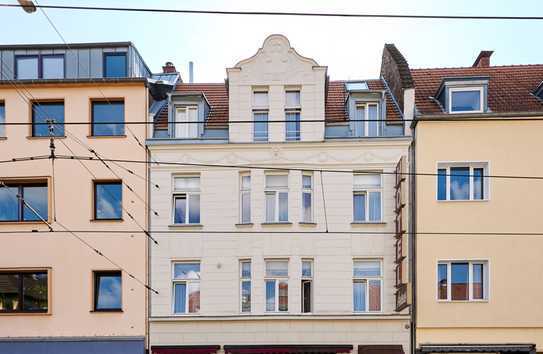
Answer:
147, 35, 412, 354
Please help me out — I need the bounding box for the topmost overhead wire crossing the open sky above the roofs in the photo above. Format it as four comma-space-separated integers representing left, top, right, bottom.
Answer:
0, 3, 543, 21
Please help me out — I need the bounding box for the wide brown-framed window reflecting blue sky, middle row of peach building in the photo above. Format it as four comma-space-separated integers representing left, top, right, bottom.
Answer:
0, 182, 49, 222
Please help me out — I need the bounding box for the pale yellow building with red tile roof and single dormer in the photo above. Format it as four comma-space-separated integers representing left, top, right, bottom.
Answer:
404, 51, 543, 353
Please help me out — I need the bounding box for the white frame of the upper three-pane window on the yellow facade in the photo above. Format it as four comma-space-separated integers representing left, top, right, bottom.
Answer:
436, 161, 490, 202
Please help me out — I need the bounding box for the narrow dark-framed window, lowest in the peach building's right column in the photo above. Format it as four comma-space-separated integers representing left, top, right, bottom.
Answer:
94, 271, 122, 311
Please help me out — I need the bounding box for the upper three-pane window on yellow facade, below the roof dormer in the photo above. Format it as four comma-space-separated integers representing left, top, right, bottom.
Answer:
437, 163, 488, 200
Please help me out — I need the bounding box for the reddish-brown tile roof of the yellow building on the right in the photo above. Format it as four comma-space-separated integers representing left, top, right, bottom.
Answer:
411, 65, 543, 115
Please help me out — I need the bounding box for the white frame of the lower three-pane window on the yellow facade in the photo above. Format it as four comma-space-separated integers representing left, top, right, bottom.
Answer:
436, 259, 490, 302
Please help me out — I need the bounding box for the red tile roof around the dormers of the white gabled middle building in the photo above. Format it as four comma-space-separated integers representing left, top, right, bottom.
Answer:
155, 80, 401, 130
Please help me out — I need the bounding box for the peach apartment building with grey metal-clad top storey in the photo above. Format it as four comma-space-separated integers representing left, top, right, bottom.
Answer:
0, 43, 164, 354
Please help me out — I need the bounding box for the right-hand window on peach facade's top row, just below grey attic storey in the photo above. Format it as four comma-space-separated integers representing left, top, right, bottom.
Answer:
91, 100, 124, 136
